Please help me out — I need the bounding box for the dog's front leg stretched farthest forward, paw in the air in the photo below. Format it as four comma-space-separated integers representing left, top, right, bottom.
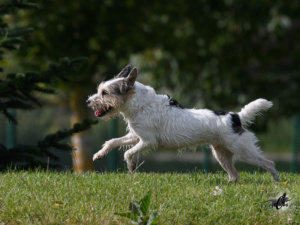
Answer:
93, 133, 139, 161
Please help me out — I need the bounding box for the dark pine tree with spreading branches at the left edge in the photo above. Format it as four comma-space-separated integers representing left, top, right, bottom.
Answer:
0, 0, 96, 170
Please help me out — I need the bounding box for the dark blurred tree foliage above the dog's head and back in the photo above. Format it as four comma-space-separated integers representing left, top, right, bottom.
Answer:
17, 0, 300, 116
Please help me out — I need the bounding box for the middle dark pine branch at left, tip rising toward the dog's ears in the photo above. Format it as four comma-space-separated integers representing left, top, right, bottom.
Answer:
0, 57, 88, 120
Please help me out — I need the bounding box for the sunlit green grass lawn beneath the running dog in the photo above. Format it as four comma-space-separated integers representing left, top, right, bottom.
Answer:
0, 171, 300, 224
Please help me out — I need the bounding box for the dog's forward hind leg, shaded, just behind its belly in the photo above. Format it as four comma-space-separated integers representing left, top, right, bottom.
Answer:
211, 145, 240, 181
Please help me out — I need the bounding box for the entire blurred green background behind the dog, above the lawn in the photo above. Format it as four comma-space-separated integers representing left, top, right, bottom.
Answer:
0, 0, 300, 172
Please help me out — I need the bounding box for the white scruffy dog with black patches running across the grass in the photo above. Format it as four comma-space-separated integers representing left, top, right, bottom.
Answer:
87, 65, 279, 181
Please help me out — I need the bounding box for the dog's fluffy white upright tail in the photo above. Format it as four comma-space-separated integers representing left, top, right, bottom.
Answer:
238, 98, 273, 127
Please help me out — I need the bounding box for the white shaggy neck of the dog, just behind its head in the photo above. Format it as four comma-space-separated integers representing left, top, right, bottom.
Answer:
120, 82, 156, 120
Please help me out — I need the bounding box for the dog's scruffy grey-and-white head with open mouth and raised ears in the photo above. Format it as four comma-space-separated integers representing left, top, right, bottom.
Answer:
86, 65, 137, 120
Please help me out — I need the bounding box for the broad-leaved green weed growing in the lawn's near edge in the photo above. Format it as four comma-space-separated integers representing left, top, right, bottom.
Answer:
115, 191, 159, 225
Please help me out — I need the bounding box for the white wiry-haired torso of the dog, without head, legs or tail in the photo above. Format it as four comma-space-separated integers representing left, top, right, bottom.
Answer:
123, 82, 239, 149
